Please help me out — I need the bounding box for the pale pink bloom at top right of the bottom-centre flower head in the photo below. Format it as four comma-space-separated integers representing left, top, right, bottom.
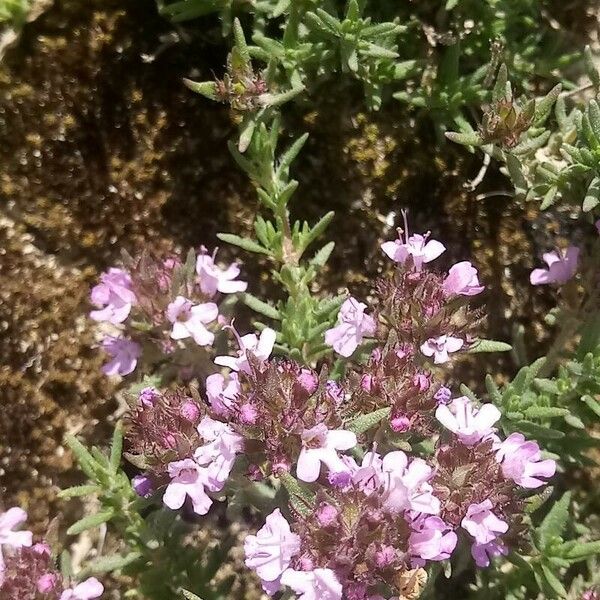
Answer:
375, 450, 440, 515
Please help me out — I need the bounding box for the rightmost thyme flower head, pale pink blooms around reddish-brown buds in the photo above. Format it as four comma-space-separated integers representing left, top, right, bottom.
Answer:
432, 397, 556, 567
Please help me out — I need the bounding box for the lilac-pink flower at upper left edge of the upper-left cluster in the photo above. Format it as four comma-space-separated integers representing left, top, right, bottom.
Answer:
90, 269, 136, 325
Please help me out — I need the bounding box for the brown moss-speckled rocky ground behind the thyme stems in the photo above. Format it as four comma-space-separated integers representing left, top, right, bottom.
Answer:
0, 0, 596, 592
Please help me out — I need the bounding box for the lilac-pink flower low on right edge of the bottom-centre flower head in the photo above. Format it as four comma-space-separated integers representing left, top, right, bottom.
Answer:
408, 516, 458, 567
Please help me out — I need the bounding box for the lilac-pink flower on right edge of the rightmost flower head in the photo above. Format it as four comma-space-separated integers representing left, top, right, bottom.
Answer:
496, 433, 556, 489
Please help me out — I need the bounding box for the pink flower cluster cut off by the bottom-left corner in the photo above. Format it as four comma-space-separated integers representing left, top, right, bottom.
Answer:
0, 507, 104, 600
